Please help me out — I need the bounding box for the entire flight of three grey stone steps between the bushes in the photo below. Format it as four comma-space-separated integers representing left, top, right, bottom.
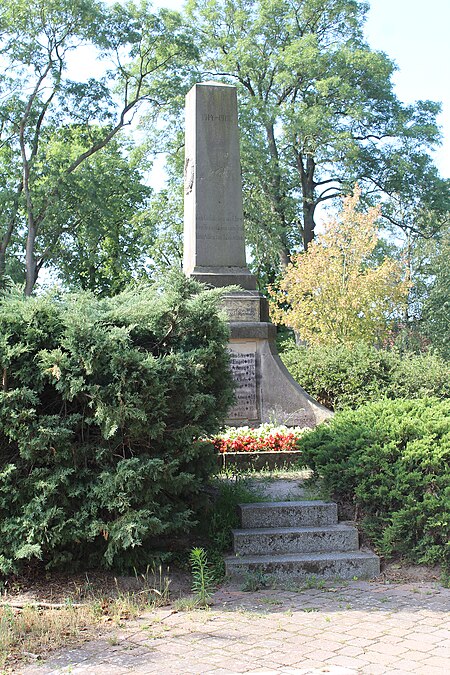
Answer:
225, 501, 380, 579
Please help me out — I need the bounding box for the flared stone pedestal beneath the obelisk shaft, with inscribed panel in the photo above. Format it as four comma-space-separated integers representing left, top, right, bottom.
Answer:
223, 291, 333, 427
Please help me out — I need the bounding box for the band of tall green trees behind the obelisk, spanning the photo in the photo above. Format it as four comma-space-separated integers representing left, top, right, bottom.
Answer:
0, 0, 450, 354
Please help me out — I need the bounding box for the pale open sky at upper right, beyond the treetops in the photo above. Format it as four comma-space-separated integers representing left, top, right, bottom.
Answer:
152, 0, 450, 178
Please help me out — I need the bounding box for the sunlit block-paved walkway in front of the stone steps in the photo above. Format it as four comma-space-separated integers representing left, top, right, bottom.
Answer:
20, 582, 450, 675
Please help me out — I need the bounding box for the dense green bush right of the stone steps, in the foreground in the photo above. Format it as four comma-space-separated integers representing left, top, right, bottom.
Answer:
302, 399, 450, 569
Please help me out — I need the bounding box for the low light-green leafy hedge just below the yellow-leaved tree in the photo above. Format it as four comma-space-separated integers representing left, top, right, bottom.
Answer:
281, 343, 450, 410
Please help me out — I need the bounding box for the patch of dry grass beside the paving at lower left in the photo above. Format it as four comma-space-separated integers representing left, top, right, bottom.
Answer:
0, 570, 170, 675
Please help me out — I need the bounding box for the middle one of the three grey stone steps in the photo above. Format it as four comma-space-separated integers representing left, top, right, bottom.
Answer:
233, 524, 359, 556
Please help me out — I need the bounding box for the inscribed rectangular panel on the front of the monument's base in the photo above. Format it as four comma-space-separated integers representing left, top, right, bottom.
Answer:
228, 351, 258, 420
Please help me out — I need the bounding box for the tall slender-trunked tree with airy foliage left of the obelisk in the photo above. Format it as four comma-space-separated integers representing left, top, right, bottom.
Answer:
0, 0, 192, 295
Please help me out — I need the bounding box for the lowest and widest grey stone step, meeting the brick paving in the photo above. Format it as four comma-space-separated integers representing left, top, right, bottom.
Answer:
225, 551, 380, 579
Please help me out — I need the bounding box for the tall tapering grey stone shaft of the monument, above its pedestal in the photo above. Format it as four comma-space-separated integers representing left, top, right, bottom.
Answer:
184, 82, 256, 289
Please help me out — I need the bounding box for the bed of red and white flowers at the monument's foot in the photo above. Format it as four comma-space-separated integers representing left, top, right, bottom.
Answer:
211, 424, 308, 454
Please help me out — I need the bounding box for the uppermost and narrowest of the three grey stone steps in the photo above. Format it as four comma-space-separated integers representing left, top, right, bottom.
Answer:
239, 501, 338, 529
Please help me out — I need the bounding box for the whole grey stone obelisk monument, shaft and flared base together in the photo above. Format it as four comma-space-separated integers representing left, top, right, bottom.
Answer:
183, 82, 331, 427
